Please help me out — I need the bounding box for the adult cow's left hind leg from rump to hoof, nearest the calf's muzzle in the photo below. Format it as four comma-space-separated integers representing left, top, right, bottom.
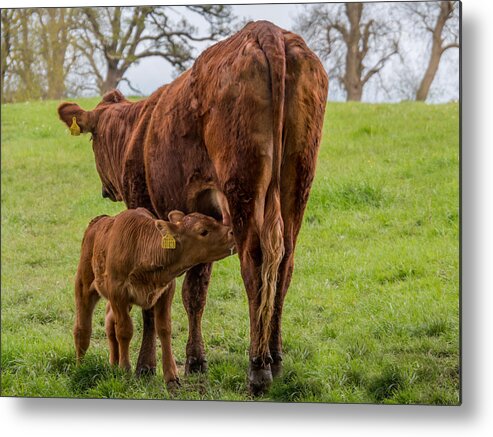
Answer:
205, 53, 283, 395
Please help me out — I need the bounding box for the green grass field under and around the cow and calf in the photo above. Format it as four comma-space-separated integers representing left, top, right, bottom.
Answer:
1, 99, 460, 405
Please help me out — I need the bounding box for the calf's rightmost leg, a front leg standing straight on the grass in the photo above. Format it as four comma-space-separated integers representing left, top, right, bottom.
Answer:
154, 281, 179, 388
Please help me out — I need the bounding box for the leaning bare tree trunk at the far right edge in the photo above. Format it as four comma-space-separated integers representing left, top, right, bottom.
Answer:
404, 1, 459, 101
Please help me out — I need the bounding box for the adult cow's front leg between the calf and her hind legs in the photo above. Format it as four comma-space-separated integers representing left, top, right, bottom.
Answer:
182, 264, 212, 375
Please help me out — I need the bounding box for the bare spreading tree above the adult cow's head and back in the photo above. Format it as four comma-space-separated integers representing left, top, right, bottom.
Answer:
76, 5, 231, 94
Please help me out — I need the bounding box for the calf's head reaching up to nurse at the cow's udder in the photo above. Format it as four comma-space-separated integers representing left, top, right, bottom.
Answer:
155, 211, 235, 266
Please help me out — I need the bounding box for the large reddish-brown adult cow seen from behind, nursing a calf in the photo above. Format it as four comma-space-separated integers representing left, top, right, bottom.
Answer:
58, 21, 328, 393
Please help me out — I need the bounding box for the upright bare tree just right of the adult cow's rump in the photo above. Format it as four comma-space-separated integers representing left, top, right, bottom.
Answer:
297, 3, 398, 101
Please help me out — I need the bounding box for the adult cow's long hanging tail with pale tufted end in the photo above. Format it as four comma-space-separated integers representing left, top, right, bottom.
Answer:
257, 23, 286, 356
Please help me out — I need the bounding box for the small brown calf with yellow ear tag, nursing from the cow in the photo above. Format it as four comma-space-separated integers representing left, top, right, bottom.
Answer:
74, 208, 234, 385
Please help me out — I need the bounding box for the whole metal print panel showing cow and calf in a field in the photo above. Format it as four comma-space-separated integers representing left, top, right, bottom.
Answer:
1, 1, 461, 405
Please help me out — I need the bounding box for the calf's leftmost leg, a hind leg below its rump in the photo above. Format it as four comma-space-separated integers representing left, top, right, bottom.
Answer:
74, 273, 100, 363
